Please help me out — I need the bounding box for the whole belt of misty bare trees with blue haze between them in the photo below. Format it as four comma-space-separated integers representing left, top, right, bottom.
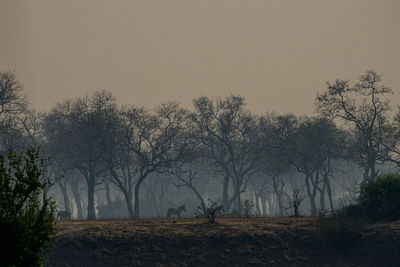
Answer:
0, 71, 400, 219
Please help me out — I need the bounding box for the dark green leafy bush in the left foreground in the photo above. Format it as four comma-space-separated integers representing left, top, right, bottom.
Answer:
0, 148, 56, 266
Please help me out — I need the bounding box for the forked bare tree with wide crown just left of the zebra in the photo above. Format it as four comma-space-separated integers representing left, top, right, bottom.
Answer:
107, 103, 189, 218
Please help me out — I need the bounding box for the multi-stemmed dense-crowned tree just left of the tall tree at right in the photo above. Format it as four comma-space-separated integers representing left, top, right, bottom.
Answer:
281, 116, 343, 216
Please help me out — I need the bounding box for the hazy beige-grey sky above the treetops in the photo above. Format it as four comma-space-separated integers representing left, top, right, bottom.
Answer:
0, 0, 400, 114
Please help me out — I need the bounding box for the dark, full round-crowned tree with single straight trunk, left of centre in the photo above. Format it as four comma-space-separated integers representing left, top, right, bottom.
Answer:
45, 90, 118, 219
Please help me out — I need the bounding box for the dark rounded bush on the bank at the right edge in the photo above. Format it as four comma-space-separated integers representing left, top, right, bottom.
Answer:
359, 174, 400, 221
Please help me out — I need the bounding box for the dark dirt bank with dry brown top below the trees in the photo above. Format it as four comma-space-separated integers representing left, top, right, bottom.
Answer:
45, 217, 400, 267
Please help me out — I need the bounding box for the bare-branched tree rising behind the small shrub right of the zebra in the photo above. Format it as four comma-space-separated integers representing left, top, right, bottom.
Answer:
191, 95, 260, 214
